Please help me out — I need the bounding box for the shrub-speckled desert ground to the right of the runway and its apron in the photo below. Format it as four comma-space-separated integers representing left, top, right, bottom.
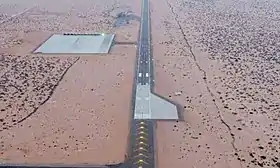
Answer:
152, 0, 280, 168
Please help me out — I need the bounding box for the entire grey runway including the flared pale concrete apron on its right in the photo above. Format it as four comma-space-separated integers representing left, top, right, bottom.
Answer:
128, 0, 179, 165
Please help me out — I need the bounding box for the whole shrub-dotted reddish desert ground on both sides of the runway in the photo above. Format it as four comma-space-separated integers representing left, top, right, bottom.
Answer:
0, 0, 280, 168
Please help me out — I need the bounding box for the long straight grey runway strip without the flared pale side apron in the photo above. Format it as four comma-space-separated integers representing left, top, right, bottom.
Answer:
128, 0, 155, 168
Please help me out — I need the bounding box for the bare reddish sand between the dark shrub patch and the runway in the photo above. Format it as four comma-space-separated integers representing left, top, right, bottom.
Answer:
1, 52, 134, 164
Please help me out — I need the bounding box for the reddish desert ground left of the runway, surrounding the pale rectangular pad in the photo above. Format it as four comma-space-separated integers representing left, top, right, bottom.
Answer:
0, 0, 140, 164
